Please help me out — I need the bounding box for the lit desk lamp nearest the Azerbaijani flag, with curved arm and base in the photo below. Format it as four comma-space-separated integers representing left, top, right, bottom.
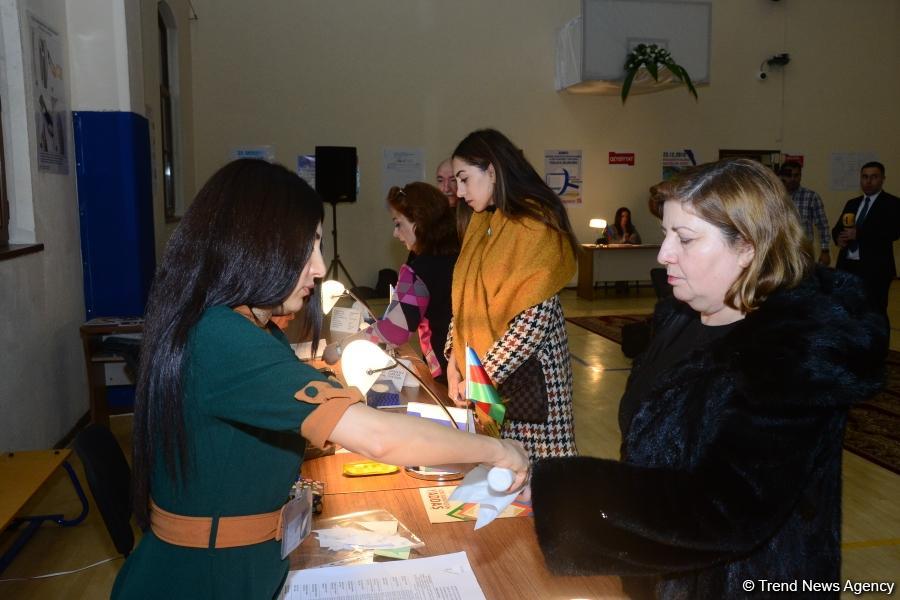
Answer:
341, 340, 465, 481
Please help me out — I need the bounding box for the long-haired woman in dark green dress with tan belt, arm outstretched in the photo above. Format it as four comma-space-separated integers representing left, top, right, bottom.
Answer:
112, 160, 528, 599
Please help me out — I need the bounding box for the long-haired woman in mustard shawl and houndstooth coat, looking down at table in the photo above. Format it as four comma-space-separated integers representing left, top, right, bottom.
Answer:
446, 129, 578, 459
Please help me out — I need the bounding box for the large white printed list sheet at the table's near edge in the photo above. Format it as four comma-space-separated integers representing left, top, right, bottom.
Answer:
279, 552, 485, 600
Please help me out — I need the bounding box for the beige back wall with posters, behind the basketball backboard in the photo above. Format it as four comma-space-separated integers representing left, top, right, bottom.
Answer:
193, 0, 900, 285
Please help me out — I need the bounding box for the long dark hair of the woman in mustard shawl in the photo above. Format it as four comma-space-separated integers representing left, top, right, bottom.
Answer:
453, 129, 579, 255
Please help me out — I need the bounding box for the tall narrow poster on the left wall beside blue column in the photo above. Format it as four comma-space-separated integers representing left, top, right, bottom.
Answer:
28, 13, 69, 175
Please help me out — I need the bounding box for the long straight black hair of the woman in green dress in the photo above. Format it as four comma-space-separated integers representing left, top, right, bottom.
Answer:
133, 159, 324, 526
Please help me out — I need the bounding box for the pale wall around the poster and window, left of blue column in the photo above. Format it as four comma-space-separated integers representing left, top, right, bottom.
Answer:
0, 0, 87, 451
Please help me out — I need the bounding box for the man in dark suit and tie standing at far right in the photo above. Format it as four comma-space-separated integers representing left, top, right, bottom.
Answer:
831, 162, 900, 312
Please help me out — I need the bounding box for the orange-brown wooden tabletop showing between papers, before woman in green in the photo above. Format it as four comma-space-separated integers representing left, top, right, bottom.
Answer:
290, 454, 623, 600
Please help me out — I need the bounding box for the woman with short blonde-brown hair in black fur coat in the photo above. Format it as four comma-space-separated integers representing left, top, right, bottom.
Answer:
531, 159, 888, 599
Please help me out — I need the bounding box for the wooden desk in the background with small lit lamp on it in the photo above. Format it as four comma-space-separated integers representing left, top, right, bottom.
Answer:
577, 244, 659, 300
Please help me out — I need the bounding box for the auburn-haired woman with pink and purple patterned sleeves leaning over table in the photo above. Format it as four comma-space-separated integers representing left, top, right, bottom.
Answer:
324, 181, 459, 384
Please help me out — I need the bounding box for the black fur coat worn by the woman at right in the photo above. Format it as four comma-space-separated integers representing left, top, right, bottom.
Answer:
532, 268, 888, 598
